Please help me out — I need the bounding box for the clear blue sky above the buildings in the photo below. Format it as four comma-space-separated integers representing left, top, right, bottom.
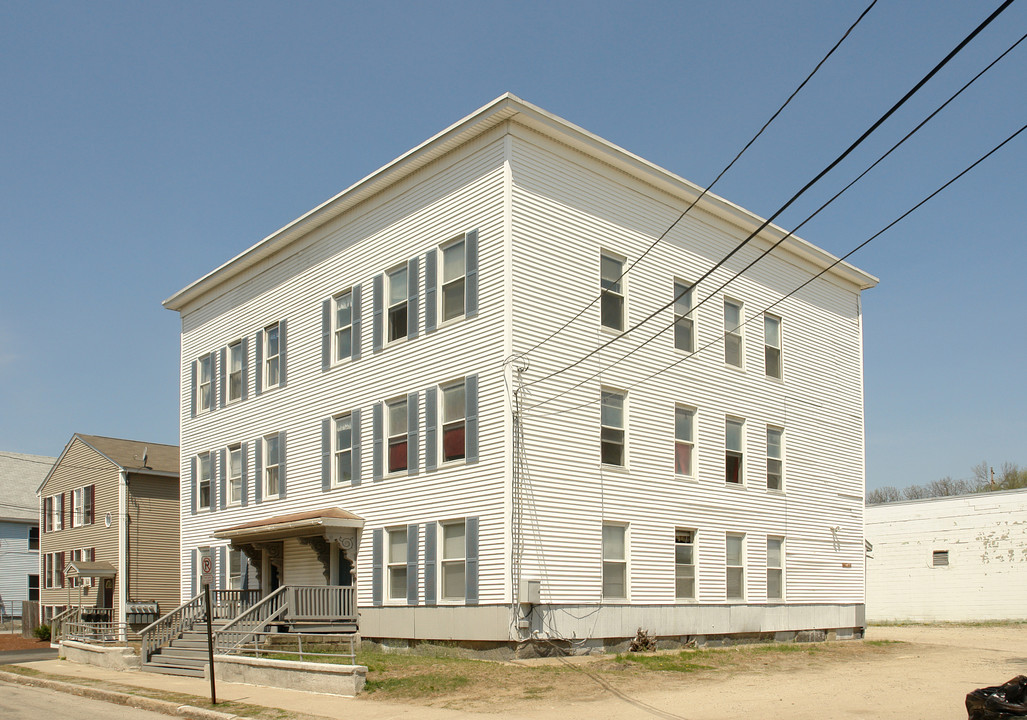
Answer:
0, 0, 1027, 488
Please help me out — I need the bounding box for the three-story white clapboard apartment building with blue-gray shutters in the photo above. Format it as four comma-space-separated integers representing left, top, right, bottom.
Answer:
164, 94, 876, 646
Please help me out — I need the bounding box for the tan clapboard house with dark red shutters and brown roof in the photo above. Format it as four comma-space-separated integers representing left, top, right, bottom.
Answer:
38, 433, 179, 630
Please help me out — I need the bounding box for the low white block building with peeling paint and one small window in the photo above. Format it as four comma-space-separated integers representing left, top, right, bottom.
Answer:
866, 489, 1027, 622
